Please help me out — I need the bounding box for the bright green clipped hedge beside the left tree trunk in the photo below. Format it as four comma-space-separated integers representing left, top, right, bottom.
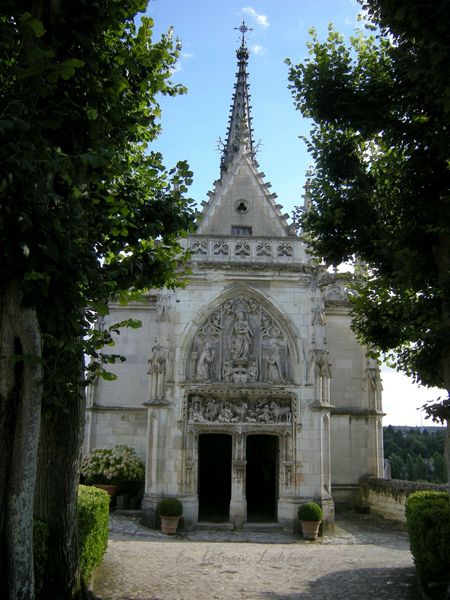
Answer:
78, 485, 109, 581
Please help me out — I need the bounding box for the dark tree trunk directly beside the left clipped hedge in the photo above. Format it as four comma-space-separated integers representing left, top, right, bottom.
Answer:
35, 355, 85, 600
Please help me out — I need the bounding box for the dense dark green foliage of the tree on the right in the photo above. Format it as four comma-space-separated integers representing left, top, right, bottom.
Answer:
289, 0, 450, 419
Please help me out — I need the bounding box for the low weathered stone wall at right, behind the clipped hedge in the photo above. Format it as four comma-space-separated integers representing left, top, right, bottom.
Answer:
360, 477, 447, 523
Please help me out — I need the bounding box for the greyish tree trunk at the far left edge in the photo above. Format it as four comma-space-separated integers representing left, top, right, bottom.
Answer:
0, 282, 42, 600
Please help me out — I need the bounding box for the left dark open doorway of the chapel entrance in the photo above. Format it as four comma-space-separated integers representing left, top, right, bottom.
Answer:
198, 433, 231, 523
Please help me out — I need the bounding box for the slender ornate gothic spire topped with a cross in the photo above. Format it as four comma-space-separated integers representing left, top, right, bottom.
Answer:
220, 21, 254, 175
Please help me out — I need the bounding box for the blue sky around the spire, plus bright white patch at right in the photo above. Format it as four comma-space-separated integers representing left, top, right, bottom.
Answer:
143, 0, 438, 425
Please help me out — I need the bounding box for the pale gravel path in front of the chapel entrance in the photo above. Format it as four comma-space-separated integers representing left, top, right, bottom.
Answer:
94, 514, 420, 600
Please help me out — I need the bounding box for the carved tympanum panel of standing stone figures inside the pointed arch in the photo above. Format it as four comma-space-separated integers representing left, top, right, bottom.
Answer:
187, 296, 292, 384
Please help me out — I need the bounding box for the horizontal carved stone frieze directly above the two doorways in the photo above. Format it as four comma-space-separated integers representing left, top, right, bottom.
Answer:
187, 395, 292, 425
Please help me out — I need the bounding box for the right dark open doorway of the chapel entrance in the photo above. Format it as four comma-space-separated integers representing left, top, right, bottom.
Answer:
246, 435, 278, 523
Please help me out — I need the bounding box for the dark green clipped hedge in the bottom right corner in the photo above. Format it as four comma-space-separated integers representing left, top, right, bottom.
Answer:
405, 490, 450, 589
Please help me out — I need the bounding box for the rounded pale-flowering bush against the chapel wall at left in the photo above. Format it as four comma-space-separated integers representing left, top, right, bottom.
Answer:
81, 445, 145, 485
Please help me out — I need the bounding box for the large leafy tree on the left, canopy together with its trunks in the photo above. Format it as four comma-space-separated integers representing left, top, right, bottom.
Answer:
0, 0, 194, 599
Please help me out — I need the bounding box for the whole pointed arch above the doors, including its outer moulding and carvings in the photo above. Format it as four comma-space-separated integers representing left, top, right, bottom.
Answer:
180, 284, 305, 385
